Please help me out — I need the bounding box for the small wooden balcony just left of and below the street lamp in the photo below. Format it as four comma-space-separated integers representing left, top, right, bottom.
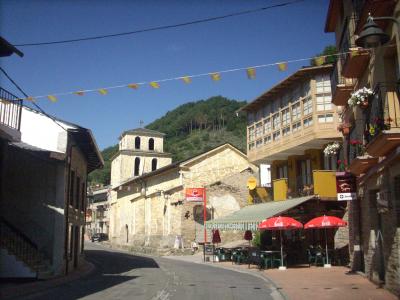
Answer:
342, 48, 370, 78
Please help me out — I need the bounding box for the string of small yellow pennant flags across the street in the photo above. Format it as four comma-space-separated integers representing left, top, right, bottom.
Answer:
17, 45, 386, 102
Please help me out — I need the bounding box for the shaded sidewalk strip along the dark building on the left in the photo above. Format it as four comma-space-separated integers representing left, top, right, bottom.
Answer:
0, 260, 96, 300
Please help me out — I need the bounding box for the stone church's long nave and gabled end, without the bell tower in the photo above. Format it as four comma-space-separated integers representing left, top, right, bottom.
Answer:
110, 140, 255, 251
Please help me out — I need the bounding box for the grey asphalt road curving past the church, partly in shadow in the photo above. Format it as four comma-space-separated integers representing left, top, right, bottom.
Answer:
23, 243, 282, 300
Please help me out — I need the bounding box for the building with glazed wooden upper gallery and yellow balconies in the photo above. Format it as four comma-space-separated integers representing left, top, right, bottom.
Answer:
241, 65, 341, 200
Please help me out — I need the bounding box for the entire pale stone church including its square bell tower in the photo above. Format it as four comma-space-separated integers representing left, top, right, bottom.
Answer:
109, 128, 257, 252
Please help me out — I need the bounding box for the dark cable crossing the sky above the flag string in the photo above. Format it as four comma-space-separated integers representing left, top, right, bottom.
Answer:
15, 0, 305, 47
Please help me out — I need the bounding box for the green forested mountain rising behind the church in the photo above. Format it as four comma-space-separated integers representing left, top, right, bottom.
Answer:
89, 96, 246, 184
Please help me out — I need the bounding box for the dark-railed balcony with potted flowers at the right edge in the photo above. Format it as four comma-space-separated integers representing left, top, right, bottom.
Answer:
366, 83, 400, 157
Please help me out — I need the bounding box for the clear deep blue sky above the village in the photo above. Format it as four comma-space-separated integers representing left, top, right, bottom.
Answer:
0, 0, 334, 149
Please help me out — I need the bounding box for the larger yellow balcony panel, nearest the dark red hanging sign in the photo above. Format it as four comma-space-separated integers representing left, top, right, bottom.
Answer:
313, 170, 337, 200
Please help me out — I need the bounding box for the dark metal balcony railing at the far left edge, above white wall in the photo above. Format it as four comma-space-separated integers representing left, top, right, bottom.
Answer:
0, 88, 22, 131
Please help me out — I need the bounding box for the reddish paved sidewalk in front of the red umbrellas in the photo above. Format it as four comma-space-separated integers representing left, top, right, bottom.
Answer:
166, 254, 398, 300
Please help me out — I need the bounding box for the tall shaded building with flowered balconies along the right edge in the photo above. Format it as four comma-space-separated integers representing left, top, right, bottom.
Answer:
325, 0, 400, 296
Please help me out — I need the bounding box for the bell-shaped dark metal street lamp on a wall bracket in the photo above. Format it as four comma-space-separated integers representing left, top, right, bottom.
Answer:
356, 15, 400, 48
